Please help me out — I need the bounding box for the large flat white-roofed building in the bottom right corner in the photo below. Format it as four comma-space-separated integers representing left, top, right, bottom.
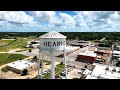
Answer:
86, 63, 120, 79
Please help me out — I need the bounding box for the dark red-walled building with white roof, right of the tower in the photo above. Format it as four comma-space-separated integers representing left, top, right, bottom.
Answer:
77, 51, 97, 63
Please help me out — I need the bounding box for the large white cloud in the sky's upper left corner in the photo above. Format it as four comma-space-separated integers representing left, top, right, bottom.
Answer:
0, 11, 36, 25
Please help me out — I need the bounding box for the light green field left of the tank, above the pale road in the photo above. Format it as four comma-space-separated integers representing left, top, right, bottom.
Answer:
0, 37, 35, 52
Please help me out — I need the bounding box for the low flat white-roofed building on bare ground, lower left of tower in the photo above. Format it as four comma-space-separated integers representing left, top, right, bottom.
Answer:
6, 60, 37, 75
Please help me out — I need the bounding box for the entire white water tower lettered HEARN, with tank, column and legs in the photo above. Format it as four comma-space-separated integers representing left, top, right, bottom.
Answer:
38, 30, 67, 79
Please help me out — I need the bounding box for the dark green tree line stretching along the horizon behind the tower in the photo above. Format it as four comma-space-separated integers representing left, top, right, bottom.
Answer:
0, 32, 120, 41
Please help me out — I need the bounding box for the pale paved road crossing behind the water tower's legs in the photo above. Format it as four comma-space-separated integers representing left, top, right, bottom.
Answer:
0, 47, 88, 67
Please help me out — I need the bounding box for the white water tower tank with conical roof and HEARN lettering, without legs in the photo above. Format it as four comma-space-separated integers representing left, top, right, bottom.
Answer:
40, 30, 67, 51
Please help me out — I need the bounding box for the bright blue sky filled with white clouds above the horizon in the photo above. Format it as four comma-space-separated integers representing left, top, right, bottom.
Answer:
0, 11, 120, 32
